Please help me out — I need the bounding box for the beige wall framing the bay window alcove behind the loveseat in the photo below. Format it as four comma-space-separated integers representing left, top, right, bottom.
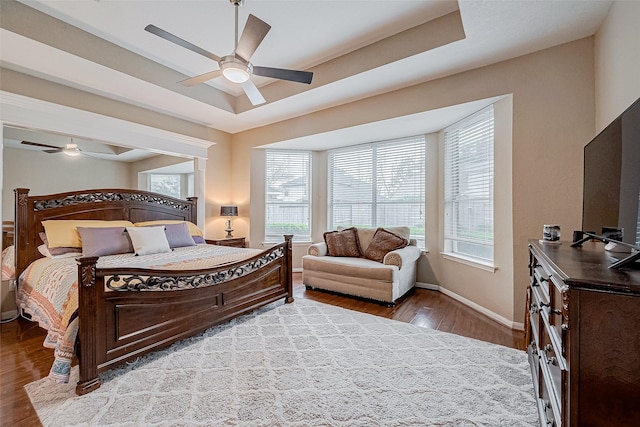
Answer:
232, 38, 595, 323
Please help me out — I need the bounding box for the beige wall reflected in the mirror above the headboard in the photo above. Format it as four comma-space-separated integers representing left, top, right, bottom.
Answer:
2, 146, 131, 221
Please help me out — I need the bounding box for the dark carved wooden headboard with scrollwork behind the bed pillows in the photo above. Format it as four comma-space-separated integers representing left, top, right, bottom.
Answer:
14, 188, 198, 277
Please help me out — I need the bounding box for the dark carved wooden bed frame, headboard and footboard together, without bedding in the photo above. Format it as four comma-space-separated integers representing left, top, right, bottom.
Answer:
14, 188, 293, 395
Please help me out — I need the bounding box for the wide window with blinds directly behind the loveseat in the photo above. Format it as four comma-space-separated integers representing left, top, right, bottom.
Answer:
328, 136, 425, 247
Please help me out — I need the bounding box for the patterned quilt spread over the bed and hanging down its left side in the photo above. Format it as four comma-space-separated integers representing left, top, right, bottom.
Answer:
17, 244, 261, 383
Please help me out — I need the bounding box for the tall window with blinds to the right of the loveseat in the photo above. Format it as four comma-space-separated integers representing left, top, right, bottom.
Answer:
444, 106, 493, 263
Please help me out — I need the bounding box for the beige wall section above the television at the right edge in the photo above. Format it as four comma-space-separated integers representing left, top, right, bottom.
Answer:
595, 1, 640, 133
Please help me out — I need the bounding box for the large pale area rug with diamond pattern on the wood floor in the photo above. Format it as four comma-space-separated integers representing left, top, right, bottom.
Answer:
25, 299, 538, 427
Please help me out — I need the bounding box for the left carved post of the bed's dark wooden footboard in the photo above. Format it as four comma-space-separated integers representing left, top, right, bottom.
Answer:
76, 257, 104, 395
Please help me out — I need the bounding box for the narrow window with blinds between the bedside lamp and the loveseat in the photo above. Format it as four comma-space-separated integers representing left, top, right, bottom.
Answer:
265, 150, 311, 242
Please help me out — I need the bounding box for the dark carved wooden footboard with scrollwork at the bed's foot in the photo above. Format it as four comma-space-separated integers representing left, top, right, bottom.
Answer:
76, 235, 293, 394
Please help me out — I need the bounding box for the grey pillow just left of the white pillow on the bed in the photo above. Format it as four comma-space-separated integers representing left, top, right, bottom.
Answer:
76, 227, 133, 256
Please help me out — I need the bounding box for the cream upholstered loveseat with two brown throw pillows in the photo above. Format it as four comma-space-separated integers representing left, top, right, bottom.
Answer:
302, 227, 421, 306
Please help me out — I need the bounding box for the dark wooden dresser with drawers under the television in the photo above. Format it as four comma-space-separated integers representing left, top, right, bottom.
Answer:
525, 240, 640, 427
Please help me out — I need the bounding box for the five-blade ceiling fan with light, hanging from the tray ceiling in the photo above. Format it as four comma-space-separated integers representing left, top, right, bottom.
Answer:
145, 0, 313, 105
